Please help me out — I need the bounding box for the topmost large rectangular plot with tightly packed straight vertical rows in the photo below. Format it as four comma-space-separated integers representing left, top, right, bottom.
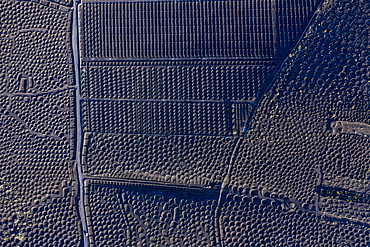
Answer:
81, 0, 276, 59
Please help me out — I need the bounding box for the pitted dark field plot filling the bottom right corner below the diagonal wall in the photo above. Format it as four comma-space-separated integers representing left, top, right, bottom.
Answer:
220, 190, 370, 246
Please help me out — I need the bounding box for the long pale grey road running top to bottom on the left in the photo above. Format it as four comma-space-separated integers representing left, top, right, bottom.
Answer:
72, 0, 89, 247
